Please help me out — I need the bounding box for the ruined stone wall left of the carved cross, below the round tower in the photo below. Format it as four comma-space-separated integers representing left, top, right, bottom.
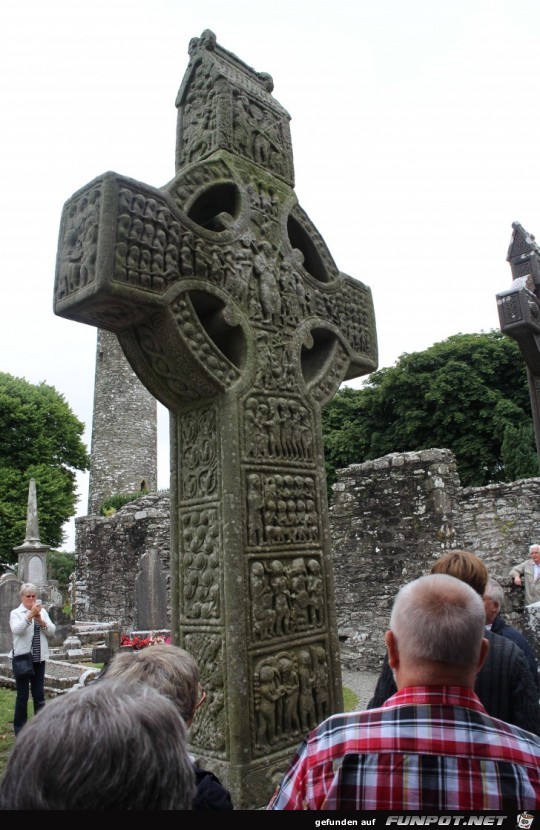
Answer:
74, 490, 170, 631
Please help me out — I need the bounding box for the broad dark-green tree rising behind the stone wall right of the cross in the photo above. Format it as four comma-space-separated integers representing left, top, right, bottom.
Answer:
323, 330, 540, 487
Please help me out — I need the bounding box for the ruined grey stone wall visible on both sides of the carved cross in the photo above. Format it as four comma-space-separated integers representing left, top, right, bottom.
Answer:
73, 449, 540, 671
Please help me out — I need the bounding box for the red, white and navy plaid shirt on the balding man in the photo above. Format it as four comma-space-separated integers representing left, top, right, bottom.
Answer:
267, 686, 540, 811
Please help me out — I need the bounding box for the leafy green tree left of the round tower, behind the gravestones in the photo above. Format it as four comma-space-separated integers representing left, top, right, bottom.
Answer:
0, 372, 90, 562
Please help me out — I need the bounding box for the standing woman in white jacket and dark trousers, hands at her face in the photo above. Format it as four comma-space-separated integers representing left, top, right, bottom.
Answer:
9, 582, 56, 735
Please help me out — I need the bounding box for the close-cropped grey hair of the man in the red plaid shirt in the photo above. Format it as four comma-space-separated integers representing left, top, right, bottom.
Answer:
390, 574, 486, 666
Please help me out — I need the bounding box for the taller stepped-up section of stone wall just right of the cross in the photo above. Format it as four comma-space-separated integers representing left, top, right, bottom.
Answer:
330, 449, 459, 671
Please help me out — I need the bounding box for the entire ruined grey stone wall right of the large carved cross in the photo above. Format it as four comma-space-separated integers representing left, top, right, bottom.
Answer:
330, 449, 540, 671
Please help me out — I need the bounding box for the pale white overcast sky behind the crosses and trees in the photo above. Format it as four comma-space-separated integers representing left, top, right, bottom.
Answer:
0, 0, 540, 549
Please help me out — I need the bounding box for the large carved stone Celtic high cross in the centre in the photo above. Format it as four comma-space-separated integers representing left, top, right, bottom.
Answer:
55, 30, 377, 809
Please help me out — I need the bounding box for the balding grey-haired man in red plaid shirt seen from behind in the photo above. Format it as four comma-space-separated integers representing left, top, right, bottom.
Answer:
267, 574, 540, 811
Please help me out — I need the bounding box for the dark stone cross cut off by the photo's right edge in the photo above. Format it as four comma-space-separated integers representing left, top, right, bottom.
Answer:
497, 222, 540, 464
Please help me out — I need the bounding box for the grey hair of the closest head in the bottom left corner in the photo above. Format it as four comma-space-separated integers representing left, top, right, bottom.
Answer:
0, 679, 195, 810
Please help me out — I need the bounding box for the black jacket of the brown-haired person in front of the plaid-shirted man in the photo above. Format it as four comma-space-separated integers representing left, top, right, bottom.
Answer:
367, 629, 540, 735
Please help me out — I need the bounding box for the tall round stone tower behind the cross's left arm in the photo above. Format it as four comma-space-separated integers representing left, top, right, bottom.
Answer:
88, 329, 157, 515
